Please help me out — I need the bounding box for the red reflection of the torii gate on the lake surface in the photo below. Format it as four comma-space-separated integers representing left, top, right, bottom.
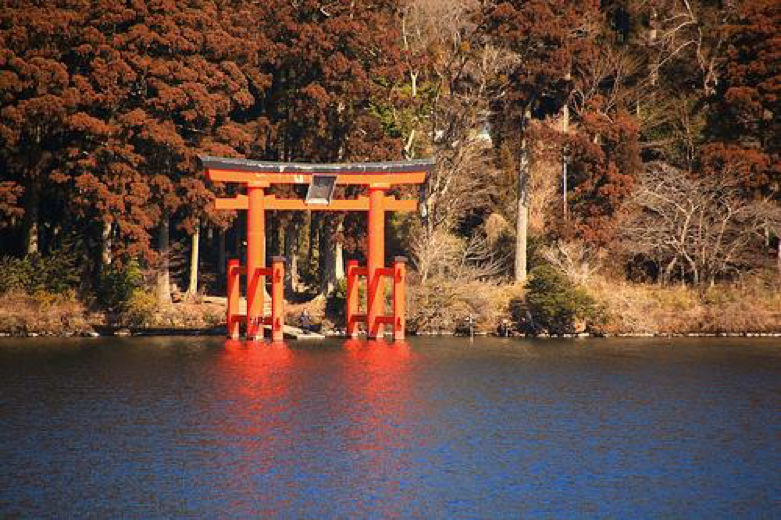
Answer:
218, 340, 414, 517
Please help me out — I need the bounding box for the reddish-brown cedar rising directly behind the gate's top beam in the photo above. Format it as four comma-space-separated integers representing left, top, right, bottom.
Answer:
257, 0, 404, 292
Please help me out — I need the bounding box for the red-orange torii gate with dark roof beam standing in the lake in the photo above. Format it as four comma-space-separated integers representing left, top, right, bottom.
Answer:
200, 156, 434, 341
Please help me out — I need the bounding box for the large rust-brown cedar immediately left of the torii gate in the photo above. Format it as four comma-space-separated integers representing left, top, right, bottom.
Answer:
66, 0, 254, 255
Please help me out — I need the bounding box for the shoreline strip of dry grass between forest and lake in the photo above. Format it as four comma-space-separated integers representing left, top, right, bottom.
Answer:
0, 280, 781, 338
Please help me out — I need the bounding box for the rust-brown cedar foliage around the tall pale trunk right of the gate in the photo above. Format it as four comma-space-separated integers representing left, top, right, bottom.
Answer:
484, 0, 639, 252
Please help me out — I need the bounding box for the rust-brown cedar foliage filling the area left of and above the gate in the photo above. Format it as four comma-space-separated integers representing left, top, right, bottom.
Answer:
0, 0, 408, 260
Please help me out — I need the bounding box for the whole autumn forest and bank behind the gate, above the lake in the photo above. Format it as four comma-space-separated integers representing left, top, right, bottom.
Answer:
0, 0, 781, 334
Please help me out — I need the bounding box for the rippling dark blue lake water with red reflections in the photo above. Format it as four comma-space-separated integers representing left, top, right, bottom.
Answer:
0, 338, 781, 519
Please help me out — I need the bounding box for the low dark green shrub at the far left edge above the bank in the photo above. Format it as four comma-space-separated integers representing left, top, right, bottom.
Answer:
0, 251, 81, 295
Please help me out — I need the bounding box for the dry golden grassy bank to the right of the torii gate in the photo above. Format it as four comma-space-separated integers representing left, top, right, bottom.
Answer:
410, 273, 781, 335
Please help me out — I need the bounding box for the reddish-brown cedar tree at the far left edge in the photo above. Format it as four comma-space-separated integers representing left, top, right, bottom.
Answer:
0, 0, 83, 253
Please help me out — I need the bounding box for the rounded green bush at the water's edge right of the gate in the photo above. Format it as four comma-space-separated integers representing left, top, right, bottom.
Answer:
514, 265, 602, 334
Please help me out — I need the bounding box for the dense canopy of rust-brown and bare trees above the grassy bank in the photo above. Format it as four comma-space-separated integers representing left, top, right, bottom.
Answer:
0, 0, 781, 300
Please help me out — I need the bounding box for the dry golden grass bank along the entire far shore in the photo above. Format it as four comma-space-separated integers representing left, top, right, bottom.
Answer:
0, 277, 781, 336
